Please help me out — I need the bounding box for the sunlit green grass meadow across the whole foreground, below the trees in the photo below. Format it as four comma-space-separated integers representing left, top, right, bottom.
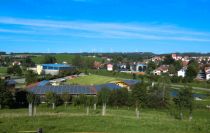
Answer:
0, 106, 210, 133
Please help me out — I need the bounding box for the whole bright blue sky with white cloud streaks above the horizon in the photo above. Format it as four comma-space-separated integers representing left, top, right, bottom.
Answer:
0, 0, 210, 53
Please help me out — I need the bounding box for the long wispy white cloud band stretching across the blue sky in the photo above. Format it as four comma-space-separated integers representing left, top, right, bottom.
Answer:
0, 18, 210, 42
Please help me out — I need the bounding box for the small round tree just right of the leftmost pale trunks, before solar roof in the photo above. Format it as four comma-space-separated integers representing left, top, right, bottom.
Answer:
45, 91, 58, 109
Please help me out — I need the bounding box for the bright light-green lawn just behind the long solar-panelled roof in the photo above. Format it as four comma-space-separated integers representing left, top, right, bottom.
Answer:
66, 75, 120, 85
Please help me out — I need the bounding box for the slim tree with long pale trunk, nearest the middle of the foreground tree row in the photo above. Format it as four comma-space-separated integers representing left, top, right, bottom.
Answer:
98, 88, 111, 116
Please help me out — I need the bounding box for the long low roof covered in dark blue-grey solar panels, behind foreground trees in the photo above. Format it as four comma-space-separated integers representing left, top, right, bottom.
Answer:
29, 85, 96, 95
